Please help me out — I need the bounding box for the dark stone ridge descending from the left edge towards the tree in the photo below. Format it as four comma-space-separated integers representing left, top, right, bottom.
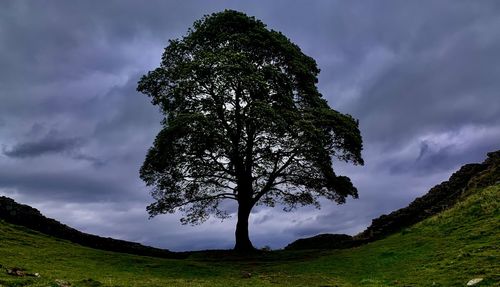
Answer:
0, 196, 183, 258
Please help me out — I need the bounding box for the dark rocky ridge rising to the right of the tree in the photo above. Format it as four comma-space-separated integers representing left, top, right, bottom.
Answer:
285, 150, 500, 249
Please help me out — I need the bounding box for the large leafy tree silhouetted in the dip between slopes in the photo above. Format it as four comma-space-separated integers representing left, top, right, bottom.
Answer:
137, 10, 363, 251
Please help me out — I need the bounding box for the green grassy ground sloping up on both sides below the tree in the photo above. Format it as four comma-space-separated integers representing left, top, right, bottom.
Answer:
0, 185, 500, 286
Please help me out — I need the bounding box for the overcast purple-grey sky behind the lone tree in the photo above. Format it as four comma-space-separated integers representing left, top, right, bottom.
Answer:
0, 0, 500, 250
